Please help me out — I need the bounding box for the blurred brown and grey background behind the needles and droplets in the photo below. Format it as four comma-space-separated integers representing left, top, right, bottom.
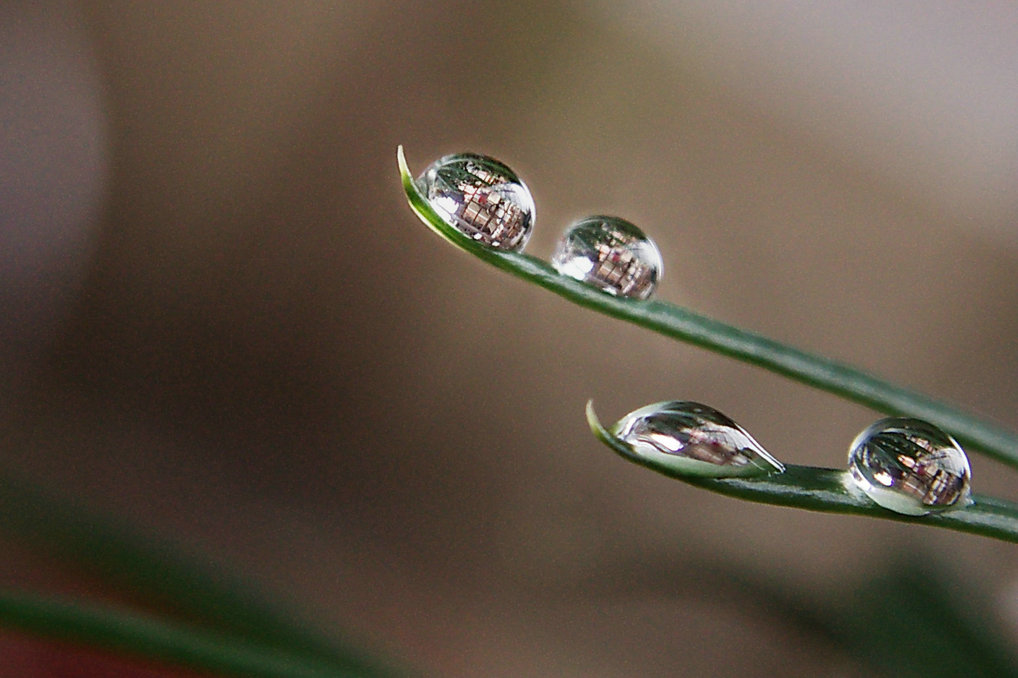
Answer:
0, 0, 1018, 677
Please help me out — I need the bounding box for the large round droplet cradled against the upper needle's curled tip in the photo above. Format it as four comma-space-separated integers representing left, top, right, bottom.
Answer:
417, 153, 534, 251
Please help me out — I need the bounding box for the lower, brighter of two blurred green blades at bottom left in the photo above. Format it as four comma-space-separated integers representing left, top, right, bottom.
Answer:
0, 591, 361, 678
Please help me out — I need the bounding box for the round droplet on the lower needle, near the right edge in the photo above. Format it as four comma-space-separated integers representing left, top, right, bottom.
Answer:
848, 417, 972, 515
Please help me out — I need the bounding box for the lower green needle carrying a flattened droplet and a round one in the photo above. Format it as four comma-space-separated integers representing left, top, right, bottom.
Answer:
586, 402, 1018, 543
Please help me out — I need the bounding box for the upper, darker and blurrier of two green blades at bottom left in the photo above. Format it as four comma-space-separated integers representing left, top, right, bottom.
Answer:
0, 473, 403, 676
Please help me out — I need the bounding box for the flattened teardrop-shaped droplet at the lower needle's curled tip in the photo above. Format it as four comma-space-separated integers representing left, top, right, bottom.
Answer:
609, 400, 785, 477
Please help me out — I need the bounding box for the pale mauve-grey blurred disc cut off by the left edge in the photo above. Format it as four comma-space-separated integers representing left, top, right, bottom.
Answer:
0, 1, 109, 384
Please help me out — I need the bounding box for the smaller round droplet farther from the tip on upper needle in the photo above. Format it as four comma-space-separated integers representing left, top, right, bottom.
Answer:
552, 216, 664, 299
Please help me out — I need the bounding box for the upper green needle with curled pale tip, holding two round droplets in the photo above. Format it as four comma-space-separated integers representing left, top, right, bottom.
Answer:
398, 147, 1018, 467
